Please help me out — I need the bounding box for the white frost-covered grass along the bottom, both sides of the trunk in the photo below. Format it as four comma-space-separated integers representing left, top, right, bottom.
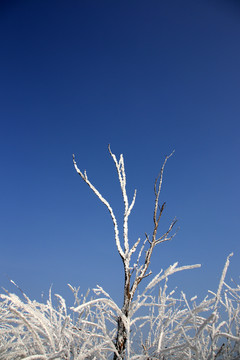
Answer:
0, 257, 240, 360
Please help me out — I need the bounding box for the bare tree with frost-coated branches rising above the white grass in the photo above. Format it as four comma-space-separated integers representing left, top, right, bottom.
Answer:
73, 146, 199, 360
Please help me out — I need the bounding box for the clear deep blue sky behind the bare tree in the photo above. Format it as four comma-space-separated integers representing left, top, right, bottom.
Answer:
0, 0, 240, 303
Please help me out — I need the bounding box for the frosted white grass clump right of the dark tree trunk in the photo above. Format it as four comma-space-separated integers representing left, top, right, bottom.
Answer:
133, 254, 240, 360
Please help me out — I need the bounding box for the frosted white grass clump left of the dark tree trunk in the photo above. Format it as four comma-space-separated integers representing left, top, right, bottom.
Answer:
0, 287, 116, 360
